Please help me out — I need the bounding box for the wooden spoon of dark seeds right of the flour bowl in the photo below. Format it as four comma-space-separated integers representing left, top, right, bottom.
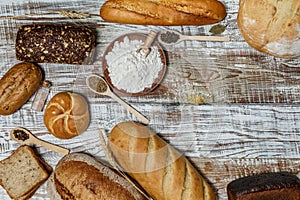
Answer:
158, 30, 230, 45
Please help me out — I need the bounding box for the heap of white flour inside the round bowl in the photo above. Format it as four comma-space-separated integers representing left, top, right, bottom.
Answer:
105, 37, 163, 93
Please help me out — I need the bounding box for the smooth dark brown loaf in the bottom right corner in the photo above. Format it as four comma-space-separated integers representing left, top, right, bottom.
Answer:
227, 172, 300, 200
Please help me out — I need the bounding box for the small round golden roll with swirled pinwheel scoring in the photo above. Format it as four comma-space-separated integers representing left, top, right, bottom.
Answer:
44, 92, 90, 139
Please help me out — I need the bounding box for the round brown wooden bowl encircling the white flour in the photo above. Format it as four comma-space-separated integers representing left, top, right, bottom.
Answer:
102, 33, 167, 96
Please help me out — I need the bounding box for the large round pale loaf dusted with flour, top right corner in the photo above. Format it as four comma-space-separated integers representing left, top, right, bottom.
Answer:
238, 0, 300, 58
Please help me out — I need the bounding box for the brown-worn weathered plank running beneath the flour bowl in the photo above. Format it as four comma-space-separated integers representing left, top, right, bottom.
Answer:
1, 29, 300, 103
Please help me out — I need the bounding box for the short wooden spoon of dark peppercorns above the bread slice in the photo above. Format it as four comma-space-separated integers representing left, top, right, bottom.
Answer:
10, 127, 70, 155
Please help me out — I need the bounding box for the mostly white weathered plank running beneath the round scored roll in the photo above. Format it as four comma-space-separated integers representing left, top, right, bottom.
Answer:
1, 103, 300, 159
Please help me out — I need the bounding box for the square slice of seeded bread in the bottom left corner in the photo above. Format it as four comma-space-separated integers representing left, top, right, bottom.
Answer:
0, 145, 50, 199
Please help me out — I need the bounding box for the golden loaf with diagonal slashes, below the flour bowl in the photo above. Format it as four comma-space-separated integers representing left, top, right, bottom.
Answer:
109, 122, 216, 200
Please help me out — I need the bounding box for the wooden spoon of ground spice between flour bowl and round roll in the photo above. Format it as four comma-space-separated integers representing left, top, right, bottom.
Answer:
86, 74, 149, 124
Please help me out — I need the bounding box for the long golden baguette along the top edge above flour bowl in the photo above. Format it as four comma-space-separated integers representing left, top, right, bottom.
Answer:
100, 0, 226, 26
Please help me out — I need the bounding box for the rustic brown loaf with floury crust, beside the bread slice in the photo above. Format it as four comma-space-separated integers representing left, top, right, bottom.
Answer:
48, 153, 145, 200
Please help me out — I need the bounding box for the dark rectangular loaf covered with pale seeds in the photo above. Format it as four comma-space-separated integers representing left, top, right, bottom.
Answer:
15, 24, 96, 64
